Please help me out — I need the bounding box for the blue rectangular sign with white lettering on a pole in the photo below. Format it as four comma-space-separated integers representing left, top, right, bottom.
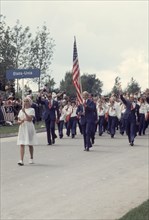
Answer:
6, 69, 40, 80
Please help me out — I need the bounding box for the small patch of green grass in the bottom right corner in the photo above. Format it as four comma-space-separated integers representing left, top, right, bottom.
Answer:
119, 200, 149, 220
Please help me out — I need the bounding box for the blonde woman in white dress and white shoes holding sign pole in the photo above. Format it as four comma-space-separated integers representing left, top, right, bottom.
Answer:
17, 97, 37, 166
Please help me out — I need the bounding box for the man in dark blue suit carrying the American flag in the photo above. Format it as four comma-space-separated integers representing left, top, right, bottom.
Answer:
77, 91, 95, 151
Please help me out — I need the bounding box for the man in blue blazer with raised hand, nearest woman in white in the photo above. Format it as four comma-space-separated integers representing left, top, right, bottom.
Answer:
38, 93, 60, 145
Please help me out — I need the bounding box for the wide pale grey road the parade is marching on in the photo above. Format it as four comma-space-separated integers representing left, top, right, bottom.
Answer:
0, 129, 149, 220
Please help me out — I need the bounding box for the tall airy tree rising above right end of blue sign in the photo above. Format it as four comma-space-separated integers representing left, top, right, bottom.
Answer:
28, 25, 55, 89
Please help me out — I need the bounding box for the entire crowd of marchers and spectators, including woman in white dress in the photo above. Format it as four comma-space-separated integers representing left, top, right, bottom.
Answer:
0, 89, 149, 165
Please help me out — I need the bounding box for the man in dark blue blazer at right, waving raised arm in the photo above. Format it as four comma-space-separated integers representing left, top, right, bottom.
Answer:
119, 88, 139, 146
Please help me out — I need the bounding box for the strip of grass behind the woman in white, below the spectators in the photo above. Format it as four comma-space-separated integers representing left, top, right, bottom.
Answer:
0, 121, 45, 134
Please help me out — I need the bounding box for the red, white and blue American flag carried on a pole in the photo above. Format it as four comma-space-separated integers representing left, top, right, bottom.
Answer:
72, 38, 83, 104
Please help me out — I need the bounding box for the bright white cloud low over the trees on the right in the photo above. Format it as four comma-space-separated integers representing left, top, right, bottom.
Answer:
81, 49, 149, 94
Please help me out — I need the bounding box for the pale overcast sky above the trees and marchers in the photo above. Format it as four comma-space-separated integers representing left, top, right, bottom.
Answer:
0, 0, 149, 94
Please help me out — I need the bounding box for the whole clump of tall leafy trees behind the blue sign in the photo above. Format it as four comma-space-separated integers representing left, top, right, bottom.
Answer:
0, 15, 55, 91
